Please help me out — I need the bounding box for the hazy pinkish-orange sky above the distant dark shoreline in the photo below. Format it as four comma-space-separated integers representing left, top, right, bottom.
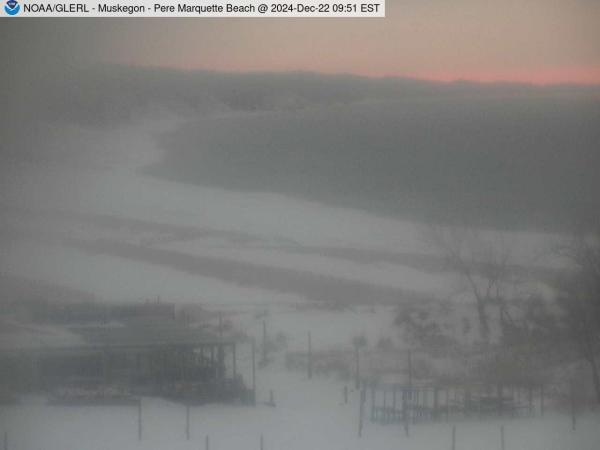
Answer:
0, 0, 600, 84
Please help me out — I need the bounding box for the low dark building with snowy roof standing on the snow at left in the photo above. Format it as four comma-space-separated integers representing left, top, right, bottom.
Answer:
0, 316, 250, 402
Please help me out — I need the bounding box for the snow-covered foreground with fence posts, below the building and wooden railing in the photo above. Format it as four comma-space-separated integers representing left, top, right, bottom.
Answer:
0, 367, 600, 450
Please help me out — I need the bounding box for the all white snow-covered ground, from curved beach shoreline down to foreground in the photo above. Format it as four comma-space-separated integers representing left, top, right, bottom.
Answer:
0, 118, 600, 450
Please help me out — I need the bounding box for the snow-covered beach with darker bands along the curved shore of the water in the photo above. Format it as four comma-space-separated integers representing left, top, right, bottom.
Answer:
0, 119, 556, 304
